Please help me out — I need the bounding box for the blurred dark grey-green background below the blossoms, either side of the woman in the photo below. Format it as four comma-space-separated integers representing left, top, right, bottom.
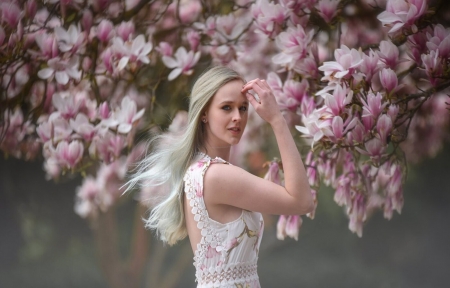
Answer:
0, 144, 450, 288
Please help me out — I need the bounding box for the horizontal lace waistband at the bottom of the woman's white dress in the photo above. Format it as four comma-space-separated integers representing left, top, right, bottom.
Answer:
198, 261, 259, 286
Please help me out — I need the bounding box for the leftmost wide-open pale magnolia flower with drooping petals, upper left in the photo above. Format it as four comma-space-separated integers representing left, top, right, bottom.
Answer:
38, 56, 81, 85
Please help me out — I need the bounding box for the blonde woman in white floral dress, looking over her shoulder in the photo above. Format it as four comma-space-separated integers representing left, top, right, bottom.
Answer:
129, 67, 313, 287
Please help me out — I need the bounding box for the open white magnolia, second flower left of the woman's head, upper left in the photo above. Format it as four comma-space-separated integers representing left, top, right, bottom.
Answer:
112, 34, 153, 71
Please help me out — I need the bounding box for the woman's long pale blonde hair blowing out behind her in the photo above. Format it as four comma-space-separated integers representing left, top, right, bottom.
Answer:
126, 66, 245, 245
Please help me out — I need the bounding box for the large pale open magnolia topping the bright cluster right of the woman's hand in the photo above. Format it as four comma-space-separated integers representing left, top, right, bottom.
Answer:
319, 45, 363, 80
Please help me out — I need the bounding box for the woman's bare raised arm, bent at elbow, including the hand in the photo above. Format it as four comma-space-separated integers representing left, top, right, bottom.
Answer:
205, 79, 313, 215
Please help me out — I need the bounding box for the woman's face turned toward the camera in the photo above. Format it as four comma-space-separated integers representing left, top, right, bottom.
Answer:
201, 80, 249, 147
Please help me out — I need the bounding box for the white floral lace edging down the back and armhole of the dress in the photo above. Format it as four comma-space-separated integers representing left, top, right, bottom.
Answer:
183, 156, 227, 278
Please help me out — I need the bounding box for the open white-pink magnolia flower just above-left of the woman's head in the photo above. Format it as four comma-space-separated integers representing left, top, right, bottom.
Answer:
162, 47, 200, 81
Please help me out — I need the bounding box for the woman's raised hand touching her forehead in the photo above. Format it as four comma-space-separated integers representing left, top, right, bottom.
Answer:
241, 78, 283, 124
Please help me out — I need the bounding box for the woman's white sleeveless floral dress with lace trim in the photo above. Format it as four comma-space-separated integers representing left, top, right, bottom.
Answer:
184, 154, 264, 288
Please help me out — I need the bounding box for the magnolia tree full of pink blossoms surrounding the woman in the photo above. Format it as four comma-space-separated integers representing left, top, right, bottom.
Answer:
0, 0, 450, 284
